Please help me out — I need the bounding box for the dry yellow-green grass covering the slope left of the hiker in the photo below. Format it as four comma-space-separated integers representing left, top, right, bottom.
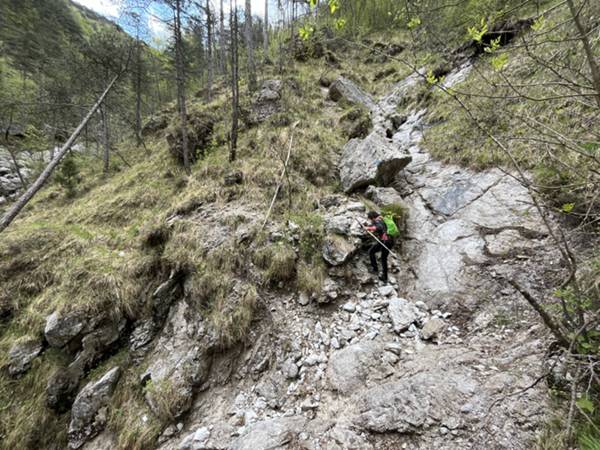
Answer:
0, 49, 356, 448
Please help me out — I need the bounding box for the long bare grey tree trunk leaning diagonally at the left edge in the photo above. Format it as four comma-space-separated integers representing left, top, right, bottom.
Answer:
0, 75, 119, 233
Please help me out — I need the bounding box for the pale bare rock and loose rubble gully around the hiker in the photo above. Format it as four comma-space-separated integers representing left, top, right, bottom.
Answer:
36, 64, 558, 450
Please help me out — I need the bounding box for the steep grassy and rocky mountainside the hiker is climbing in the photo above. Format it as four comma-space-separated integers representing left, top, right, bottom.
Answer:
0, 0, 596, 450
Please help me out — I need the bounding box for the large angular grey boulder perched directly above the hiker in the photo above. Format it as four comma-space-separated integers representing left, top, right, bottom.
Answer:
339, 132, 412, 193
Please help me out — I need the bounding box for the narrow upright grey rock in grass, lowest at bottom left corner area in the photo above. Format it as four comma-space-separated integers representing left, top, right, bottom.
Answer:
69, 367, 121, 449
